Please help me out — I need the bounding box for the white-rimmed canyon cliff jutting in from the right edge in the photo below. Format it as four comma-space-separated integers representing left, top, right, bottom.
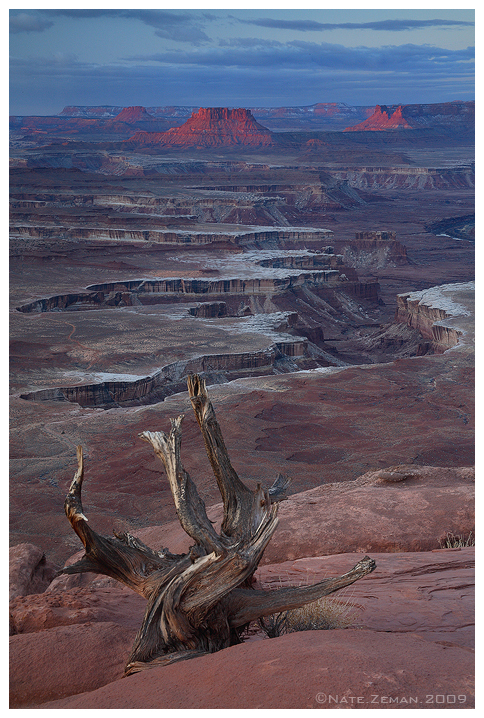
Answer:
395, 282, 474, 354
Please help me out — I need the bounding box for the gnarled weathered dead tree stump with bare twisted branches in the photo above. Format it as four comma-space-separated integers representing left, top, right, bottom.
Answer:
61, 375, 375, 674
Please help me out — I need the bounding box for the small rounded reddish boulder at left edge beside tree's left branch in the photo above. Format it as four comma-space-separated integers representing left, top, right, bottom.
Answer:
9, 543, 58, 600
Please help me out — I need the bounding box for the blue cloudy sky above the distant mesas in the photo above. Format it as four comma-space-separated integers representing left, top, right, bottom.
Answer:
9, 1, 475, 115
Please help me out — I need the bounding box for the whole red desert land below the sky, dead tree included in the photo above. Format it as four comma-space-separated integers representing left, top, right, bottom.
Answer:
9, 11, 475, 710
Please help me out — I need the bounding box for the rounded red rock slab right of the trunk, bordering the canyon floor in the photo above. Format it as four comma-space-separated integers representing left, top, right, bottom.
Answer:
262, 465, 475, 563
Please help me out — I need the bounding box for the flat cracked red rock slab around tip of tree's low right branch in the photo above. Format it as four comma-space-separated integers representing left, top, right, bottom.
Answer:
256, 547, 475, 649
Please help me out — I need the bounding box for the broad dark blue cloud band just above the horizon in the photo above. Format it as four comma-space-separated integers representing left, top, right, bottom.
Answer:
10, 43, 474, 114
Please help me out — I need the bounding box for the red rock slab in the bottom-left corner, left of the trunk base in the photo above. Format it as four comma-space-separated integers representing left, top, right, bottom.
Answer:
10, 622, 136, 708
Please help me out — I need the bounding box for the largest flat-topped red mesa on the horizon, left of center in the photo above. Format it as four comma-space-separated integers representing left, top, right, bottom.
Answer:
127, 107, 273, 147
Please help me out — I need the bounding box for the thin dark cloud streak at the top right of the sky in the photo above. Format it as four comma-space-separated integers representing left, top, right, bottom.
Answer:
236, 18, 474, 32
